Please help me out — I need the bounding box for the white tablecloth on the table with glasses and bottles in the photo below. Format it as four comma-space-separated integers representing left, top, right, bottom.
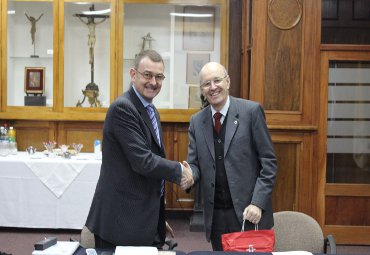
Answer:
0, 152, 101, 229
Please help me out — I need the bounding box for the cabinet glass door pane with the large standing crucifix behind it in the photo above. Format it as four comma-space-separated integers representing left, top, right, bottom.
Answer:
64, 2, 111, 107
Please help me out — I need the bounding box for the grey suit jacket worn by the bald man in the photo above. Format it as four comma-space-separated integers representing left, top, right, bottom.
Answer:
188, 96, 277, 241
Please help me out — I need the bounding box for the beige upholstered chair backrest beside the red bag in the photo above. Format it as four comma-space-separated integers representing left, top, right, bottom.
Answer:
274, 211, 324, 253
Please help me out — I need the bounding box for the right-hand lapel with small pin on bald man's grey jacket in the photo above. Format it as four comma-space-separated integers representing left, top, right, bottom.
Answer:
224, 97, 239, 157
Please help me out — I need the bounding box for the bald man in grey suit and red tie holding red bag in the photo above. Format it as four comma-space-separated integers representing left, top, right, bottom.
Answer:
188, 62, 277, 251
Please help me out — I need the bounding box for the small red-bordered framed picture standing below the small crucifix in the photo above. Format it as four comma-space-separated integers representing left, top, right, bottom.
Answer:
24, 67, 45, 94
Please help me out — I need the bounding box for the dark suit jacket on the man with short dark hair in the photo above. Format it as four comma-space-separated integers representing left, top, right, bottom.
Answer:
86, 87, 181, 246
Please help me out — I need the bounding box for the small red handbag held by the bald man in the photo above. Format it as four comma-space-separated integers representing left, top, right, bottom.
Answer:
221, 220, 275, 252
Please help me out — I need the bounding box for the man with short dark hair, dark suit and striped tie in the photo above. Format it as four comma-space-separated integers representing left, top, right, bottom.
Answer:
86, 50, 193, 248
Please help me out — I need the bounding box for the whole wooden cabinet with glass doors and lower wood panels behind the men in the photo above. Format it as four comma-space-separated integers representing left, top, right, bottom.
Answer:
0, 0, 229, 210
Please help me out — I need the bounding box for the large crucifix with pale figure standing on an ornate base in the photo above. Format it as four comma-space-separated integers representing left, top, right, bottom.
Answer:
73, 5, 109, 107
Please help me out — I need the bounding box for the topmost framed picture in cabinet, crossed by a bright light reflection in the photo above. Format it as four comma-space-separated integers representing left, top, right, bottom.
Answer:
183, 6, 215, 51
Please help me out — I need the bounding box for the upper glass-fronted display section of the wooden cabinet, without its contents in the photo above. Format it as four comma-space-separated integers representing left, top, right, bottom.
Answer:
0, 0, 227, 122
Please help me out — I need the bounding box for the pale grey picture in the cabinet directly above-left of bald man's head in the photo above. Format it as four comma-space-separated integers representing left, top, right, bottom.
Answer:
186, 53, 210, 84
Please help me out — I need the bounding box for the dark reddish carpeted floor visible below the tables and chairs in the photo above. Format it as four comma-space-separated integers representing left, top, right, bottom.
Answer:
0, 218, 370, 255
